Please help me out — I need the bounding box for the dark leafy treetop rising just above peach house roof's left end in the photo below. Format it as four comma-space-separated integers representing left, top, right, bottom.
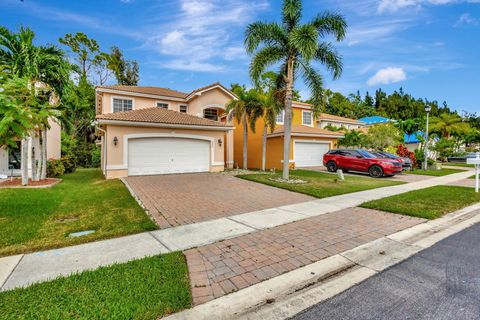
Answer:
104, 46, 139, 86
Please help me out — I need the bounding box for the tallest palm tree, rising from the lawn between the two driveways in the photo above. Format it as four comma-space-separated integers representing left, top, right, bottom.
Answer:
245, 0, 347, 179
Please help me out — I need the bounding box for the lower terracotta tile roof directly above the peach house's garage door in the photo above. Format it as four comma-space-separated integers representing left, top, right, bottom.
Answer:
97, 107, 232, 128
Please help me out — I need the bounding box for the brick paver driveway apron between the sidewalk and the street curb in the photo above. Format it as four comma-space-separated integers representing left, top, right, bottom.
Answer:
184, 208, 424, 304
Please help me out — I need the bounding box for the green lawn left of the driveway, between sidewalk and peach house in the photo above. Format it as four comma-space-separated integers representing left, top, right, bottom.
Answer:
0, 169, 156, 256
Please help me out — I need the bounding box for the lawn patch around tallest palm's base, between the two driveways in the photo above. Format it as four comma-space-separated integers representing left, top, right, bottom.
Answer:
237, 170, 402, 198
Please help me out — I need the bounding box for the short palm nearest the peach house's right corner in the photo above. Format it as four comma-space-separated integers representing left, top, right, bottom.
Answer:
225, 85, 260, 169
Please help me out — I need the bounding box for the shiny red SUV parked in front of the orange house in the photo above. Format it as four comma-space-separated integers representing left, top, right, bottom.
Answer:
323, 149, 402, 178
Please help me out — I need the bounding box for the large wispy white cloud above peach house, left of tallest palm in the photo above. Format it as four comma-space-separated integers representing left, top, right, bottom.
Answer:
144, 0, 268, 72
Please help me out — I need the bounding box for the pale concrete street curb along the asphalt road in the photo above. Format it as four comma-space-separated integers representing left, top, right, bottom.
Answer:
166, 203, 480, 320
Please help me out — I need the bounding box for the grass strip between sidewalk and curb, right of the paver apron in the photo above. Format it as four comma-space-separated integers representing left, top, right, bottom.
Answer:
361, 186, 480, 219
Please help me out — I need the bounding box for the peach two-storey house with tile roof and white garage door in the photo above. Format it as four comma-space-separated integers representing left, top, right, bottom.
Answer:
96, 83, 237, 179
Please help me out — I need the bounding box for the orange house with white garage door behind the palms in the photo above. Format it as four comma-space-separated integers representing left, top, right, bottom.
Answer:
234, 102, 344, 170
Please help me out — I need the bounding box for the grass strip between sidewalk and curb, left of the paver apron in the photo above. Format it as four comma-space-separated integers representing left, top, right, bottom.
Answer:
0, 252, 191, 320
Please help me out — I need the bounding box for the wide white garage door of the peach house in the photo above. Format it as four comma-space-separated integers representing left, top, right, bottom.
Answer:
128, 138, 210, 175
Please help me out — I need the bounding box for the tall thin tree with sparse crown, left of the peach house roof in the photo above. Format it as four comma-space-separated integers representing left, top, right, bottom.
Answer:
58, 32, 100, 78
